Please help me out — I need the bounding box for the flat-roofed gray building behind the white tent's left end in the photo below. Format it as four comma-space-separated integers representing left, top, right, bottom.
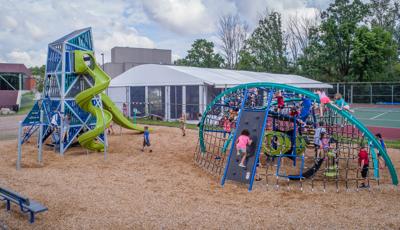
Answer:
104, 47, 172, 78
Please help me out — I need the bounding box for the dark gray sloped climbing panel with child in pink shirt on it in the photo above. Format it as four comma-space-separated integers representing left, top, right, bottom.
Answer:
226, 110, 266, 184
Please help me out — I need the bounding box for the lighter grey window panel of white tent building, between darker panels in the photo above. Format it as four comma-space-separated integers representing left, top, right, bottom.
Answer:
148, 86, 165, 117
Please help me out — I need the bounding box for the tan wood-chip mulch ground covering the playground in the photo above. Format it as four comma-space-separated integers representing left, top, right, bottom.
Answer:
0, 127, 400, 229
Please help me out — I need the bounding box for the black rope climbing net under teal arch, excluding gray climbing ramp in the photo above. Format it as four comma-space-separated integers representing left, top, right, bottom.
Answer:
194, 84, 397, 191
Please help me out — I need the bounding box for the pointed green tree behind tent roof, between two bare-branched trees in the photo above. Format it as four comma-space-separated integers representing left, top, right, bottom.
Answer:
244, 12, 287, 73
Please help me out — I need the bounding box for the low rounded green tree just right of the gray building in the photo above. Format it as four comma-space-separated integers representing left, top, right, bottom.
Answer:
175, 39, 224, 68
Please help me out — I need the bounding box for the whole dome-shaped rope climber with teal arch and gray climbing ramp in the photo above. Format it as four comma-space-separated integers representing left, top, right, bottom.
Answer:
194, 83, 398, 192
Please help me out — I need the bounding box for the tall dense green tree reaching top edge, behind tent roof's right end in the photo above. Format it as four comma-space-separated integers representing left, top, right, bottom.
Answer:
300, 0, 369, 81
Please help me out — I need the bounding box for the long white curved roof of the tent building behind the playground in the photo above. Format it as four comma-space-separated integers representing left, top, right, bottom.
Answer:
110, 64, 332, 88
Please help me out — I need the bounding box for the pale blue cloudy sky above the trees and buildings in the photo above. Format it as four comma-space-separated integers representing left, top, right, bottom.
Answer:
0, 0, 332, 67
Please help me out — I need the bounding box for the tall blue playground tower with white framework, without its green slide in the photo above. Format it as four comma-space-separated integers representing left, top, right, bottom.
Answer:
17, 27, 107, 168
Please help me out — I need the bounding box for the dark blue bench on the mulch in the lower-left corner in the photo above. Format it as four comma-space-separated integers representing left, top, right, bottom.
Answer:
0, 187, 48, 223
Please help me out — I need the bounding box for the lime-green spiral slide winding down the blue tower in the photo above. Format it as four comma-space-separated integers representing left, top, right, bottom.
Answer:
74, 50, 144, 151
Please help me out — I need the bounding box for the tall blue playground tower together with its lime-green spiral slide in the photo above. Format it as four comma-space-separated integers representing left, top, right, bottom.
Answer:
17, 28, 143, 169
